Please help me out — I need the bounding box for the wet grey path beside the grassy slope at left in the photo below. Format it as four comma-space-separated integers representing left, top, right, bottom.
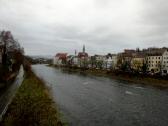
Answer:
0, 67, 24, 120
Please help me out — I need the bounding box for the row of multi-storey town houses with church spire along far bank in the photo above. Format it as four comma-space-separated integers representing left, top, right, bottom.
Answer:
53, 46, 168, 75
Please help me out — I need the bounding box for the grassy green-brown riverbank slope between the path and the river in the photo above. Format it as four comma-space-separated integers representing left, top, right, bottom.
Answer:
0, 70, 63, 126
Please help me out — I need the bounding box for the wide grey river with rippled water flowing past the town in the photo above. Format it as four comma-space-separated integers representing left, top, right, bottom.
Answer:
32, 65, 168, 126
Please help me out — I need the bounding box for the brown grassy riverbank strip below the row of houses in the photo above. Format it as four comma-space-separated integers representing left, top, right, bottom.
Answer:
48, 65, 168, 89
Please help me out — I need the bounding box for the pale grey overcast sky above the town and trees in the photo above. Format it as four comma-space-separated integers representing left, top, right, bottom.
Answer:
0, 0, 168, 55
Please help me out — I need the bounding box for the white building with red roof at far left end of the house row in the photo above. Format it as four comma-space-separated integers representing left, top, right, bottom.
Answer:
53, 53, 67, 66
